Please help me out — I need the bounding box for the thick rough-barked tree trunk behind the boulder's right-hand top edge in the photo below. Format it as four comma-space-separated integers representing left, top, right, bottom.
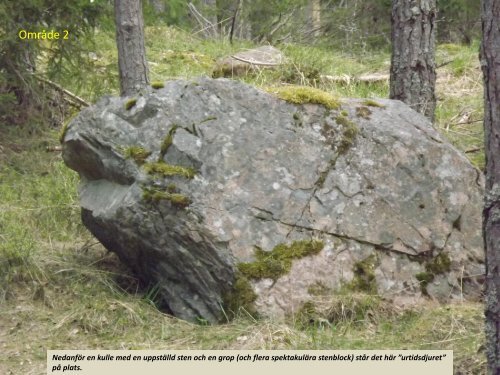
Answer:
390, 0, 437, 121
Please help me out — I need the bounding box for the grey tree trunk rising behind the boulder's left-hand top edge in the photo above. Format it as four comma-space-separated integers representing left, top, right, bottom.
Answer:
115, 0, 149, 96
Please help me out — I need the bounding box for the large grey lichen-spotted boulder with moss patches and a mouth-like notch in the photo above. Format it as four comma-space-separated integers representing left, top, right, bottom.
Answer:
63, 78, 484, 322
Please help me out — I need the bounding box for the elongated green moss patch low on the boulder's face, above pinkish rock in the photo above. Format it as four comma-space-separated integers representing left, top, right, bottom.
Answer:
238, 240, 324, 281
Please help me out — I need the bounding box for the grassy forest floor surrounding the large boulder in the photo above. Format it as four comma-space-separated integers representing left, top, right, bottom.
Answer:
0, 27, 486, 375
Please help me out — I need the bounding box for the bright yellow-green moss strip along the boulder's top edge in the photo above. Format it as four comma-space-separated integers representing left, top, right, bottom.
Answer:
267, 86, 340, 109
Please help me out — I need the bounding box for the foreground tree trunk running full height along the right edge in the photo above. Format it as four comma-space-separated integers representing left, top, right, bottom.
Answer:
481, 0, 500, 374
